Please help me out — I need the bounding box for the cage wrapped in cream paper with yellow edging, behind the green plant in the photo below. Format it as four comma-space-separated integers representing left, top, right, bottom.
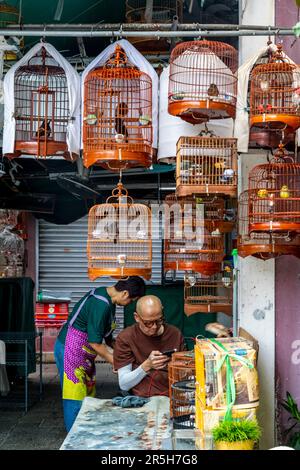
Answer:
195, 337, 259, 450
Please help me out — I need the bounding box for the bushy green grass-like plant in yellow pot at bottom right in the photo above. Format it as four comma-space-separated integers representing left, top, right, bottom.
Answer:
212, 420, 261, 450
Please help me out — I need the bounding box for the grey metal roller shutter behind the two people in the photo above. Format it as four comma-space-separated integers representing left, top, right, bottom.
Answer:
38, 211, 162, 330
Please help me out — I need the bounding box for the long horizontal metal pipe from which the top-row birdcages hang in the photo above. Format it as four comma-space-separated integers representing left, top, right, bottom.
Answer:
0, 25, 294, 39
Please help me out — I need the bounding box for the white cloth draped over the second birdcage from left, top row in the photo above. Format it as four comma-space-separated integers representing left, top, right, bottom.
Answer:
81, 39, 158, 148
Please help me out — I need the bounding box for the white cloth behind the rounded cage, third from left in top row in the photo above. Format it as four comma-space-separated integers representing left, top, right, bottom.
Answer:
157, 65, 233, 163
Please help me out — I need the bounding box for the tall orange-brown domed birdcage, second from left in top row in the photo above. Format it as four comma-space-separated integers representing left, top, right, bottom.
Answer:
83, 45, 152, 170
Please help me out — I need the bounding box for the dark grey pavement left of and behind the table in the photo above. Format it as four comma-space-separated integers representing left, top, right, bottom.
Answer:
0, 363, 118, 450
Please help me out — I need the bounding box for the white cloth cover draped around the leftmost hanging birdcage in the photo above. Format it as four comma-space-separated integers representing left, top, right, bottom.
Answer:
3, 42, 80, 155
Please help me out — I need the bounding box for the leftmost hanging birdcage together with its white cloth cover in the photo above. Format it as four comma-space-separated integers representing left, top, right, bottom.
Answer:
3, 42, 80, 160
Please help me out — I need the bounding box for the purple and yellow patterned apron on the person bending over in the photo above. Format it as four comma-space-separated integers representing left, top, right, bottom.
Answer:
63, 289, 112, 401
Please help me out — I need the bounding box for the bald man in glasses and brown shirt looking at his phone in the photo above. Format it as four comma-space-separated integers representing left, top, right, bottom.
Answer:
113, 295, 184, 397
